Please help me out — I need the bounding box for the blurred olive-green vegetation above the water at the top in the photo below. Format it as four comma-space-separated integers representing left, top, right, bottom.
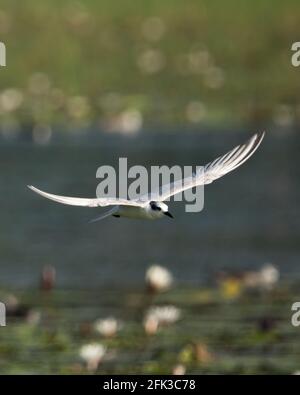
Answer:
0, 0, 300, 131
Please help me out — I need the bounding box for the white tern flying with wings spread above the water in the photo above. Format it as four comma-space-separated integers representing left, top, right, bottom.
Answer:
28, 132, 265, 222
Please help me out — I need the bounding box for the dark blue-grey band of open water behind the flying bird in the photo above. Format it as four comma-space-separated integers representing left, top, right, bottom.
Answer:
0, 131, 300, 288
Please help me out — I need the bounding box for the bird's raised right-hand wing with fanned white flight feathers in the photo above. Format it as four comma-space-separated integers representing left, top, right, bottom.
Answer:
150, 132, 265, 201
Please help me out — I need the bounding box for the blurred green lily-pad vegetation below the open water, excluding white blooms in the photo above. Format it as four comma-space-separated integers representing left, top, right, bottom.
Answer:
0, 285, 300, 374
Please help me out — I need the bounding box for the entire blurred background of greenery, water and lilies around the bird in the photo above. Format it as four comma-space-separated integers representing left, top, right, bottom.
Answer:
0, 0, 300, 374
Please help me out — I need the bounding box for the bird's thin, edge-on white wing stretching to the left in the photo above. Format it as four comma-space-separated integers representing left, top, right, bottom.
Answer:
28, 185, 145, 207
